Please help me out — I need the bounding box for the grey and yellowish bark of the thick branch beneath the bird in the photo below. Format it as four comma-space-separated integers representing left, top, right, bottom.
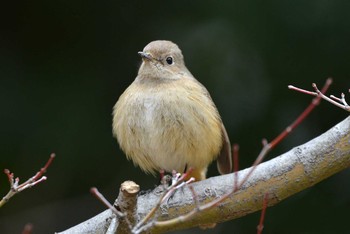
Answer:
57, 117, 350, 234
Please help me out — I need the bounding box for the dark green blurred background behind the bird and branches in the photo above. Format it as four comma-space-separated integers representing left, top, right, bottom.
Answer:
0, 0, 350, 233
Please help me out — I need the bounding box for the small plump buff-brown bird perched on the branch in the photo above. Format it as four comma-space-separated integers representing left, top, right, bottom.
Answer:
113, 41, 232, 180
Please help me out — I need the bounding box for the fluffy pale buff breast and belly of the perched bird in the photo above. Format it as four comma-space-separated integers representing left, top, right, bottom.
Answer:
113, 80, 222, 174
